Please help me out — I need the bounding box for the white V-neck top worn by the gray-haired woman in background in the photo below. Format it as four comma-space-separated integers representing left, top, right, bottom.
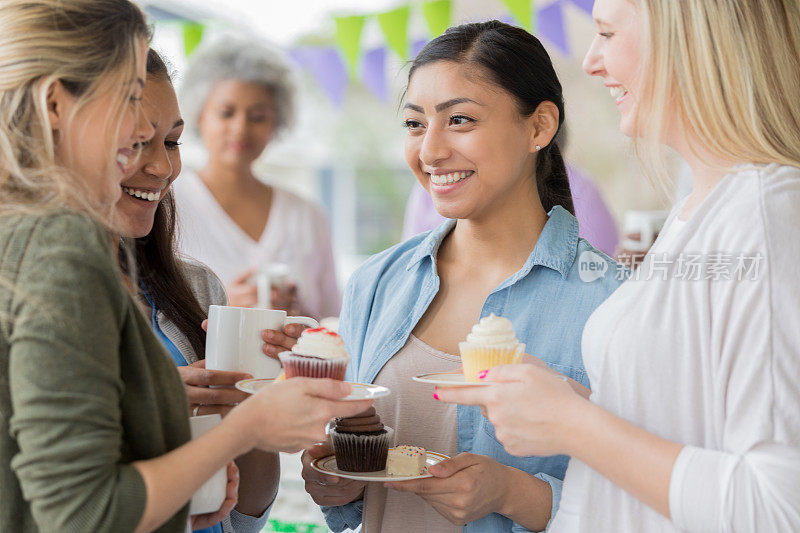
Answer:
173, 171, 341, 318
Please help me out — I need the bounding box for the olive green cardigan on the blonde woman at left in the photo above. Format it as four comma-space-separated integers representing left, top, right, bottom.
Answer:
0, 211, 189, 533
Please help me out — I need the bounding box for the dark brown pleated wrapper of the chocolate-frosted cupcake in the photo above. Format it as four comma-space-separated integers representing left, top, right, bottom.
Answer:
331, 426, 394, 472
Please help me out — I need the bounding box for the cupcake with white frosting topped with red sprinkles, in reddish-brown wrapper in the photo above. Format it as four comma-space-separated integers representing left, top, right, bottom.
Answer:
278, 328, 350, 381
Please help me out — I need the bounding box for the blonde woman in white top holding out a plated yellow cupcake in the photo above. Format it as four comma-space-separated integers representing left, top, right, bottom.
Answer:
438, 0, 800, 533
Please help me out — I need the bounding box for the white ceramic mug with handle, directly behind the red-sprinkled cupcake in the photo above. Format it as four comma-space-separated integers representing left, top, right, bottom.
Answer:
206, 305, 319, 378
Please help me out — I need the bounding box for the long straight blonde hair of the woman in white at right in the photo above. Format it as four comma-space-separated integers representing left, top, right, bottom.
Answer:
630, 0, 800, 179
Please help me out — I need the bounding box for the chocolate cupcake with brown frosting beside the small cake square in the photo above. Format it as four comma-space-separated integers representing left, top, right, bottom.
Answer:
331, 407, 394, 472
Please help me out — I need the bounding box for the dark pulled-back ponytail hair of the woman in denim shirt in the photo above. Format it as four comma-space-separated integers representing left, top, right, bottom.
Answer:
408, 20, 575, 215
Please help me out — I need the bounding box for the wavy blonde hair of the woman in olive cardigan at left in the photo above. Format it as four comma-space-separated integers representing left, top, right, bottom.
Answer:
0, 0, 150, 218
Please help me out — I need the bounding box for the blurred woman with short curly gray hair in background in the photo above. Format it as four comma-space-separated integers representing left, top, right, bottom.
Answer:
175, 39, 341, 318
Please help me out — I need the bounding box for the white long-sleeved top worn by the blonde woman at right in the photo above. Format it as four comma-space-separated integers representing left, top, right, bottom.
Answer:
549, 165, 800, 533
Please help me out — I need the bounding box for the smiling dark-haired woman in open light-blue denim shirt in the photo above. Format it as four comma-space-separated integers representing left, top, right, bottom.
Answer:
272, 21, 619, 533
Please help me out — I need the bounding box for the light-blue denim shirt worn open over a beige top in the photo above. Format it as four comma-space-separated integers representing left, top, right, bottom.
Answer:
322, 206, 621, 533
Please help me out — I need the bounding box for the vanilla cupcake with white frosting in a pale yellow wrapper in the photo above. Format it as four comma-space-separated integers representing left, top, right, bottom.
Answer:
458, 313, 525, 381
